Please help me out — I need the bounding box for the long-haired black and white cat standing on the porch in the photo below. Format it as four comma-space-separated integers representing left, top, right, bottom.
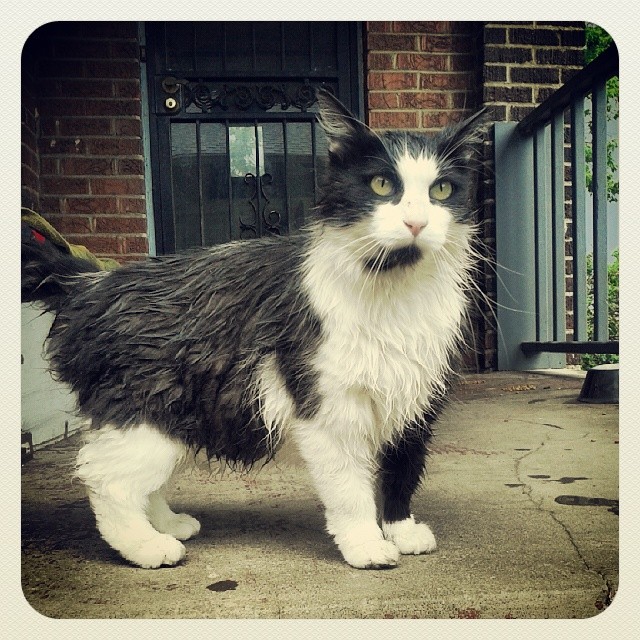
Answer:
23, 91, 480, 568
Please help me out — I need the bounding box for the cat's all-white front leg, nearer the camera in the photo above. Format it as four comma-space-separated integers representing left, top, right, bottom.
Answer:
296, 416, 399, 569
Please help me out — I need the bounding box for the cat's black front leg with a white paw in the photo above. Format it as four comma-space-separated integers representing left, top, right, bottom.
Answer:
380, 425, 436, 555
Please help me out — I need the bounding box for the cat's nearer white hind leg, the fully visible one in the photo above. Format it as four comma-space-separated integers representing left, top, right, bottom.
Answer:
76, 424, 185, 568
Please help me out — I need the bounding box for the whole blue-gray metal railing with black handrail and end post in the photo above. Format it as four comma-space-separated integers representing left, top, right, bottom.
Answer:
494, 45, 619, 369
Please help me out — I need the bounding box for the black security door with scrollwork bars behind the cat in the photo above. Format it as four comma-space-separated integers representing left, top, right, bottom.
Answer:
146, 22, 362, 254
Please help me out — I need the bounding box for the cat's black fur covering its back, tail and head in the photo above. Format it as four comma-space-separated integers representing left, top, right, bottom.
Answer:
23, 93, 484, 465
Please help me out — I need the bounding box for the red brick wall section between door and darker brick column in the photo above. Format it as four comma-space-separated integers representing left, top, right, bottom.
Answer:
366, 22, 482, 130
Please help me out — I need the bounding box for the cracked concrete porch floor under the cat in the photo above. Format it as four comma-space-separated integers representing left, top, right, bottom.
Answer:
22, 373, 619, 619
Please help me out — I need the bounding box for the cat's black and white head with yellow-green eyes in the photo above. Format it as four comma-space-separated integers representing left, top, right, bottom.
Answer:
318, 91, 483, 270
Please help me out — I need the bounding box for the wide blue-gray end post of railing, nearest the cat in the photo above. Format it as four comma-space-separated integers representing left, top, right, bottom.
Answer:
494, 122, 564, 370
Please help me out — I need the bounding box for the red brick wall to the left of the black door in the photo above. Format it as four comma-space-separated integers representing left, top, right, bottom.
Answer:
23, 22, 148, 262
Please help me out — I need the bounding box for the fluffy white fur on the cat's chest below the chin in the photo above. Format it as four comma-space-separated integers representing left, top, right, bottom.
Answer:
305, 230, 466, 441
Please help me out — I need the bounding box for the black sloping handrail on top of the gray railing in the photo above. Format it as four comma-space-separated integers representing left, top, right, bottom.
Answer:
516, 43, 618, 134
